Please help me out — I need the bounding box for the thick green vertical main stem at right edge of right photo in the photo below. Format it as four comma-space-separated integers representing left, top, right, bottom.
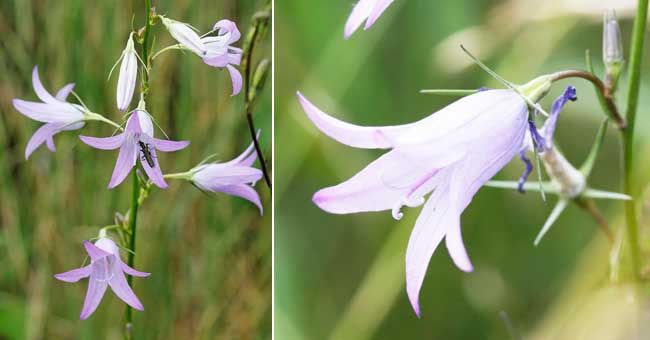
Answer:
623, 0, 648, 278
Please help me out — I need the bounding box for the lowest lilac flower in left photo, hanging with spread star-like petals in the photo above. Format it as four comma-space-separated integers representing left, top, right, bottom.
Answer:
54, 238, 151, 320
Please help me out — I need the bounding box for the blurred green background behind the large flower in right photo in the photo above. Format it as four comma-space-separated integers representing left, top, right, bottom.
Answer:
274, 0, 650, 340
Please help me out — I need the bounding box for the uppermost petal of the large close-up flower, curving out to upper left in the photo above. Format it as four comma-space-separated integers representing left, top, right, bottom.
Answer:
297, 91, 414, 149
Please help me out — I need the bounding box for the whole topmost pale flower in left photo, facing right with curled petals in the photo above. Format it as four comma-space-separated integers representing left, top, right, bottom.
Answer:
161, 17, 243, 96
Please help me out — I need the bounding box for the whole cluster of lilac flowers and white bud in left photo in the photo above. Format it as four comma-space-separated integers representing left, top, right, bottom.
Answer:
13, 9, 262, 320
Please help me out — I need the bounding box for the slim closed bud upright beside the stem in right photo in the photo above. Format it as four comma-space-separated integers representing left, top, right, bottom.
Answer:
603, 10, 625, 89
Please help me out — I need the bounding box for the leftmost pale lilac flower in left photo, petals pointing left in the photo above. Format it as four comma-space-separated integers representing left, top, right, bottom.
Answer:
13, 66, 87, 159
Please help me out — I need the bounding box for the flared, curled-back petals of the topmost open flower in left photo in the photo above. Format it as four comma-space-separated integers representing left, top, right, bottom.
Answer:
201, 20, 243, 96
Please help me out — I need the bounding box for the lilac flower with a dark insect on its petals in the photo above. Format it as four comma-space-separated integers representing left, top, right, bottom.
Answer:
79, 109, 190, 189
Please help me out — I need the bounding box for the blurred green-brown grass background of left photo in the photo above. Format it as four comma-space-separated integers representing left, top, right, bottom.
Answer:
0, 0, 272, 339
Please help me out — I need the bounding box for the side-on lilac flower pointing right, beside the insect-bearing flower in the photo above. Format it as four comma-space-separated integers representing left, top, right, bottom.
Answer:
170, 132, 264, 214
